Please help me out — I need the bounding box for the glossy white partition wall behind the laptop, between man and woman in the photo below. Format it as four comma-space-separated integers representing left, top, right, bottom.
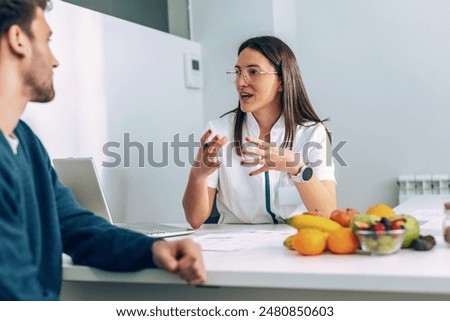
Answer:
24, 1, 203, 223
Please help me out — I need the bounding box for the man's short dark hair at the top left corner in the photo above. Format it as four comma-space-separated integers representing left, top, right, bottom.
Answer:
0, 0, 49, 37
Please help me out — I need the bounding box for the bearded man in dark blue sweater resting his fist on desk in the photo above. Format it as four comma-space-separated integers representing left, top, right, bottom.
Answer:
0, 0, 206, 300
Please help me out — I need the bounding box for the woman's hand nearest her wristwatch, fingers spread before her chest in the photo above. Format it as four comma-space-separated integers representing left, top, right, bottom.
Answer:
241, 137, 305, 176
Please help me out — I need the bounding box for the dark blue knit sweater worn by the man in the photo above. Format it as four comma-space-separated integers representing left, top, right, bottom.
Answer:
0, 121, 154, 300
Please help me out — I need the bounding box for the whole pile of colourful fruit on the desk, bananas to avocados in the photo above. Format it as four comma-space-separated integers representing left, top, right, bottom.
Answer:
283, 204, 436, 255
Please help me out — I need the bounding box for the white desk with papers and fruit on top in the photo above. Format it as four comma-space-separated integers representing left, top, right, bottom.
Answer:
61, 215, 450, 301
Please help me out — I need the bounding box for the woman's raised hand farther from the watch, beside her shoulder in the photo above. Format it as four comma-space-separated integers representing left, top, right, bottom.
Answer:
192, 129, 228, 178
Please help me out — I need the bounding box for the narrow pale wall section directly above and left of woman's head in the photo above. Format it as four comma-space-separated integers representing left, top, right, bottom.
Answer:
191, 0, 274, 125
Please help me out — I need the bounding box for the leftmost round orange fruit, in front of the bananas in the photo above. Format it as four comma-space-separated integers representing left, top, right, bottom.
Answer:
294, 228, 328, 255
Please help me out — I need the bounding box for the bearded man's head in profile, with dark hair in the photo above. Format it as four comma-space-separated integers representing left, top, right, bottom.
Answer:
0, 0, 58, 102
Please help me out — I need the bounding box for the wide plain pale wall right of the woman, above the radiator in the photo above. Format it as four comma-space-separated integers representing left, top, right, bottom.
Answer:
296, 0, 450, 210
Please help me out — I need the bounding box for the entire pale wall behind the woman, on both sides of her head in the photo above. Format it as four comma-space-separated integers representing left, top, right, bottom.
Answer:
192, 0, 450, 211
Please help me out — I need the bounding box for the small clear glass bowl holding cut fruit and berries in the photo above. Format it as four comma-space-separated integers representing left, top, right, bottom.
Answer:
355, 229, 405, 255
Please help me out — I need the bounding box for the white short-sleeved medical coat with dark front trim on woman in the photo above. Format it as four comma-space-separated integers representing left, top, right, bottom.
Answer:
207, 113, 336, 224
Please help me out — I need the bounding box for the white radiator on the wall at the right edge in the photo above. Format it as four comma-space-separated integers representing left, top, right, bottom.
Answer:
397, 174, 450, 203
